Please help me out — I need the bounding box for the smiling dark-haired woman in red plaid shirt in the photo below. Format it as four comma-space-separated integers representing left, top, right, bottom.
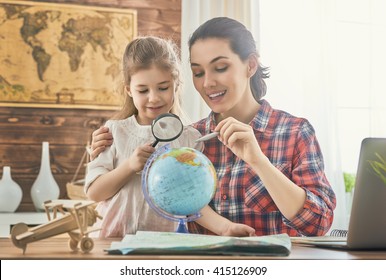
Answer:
92, 17, 336, 236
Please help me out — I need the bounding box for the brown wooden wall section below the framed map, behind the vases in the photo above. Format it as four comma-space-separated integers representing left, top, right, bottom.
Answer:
0, 107, 114, 211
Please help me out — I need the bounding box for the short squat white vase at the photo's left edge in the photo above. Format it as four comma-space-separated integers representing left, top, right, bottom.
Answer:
0, 166, 23, 212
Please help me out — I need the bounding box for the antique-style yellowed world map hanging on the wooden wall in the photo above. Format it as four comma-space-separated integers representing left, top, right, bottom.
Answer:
0, 0, 137, 109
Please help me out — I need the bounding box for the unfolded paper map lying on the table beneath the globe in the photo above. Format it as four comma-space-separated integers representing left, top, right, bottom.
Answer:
106, 231, 291, 256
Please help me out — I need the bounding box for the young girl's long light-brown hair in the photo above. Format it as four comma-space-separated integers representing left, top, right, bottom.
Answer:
114, 36, 182, 119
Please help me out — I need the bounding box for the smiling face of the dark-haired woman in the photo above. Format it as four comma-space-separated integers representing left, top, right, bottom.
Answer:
190, 38, 253, 117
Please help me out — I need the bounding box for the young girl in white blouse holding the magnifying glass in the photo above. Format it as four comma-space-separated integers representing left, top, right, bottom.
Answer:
85, 37, 254, 237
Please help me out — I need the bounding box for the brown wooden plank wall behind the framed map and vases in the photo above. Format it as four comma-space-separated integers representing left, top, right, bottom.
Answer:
0, 0, 181, 212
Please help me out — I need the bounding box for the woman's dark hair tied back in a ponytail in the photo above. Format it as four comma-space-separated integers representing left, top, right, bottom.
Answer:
188, 17, 269, 101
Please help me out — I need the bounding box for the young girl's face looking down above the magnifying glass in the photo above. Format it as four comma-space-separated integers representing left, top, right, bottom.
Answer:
126, 65, 175, 125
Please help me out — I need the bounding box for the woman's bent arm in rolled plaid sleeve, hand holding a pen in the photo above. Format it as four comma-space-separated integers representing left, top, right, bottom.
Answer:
216, 118, 336, 235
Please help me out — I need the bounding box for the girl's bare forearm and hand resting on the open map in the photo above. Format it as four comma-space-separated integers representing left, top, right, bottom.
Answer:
196, 206, 255, 236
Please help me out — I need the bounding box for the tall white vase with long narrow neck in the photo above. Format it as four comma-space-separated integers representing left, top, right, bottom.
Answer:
31, 142, 60, 211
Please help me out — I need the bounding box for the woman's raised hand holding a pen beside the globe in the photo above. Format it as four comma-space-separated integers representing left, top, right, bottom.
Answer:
215, 117, 263, 164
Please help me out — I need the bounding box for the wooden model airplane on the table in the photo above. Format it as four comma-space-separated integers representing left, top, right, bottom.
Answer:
11, 199, 102, 254
